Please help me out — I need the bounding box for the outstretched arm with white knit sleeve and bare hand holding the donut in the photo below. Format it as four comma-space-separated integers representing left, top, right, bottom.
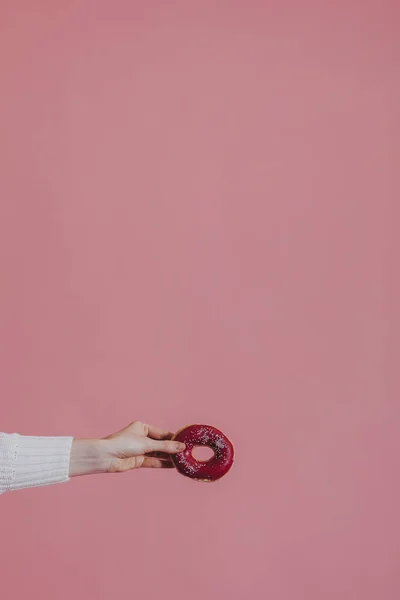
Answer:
0, 421, 185, 494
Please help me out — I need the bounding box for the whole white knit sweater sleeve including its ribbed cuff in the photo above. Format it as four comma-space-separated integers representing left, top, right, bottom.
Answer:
0, 433, 73, 494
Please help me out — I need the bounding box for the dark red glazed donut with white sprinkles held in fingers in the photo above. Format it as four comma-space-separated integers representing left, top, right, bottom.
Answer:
171, 425, 234, 481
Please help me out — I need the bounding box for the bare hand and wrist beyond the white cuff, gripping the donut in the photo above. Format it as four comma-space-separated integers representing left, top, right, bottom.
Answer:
69, 421, 185, 477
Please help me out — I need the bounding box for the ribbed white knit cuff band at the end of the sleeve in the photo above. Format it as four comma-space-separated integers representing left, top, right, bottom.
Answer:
8, 434, 73, 491
